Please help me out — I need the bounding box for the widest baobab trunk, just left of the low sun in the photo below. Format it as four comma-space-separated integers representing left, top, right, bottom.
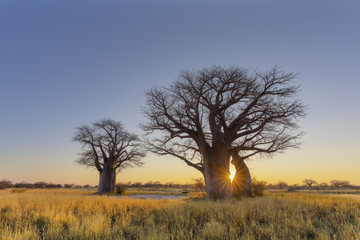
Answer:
203, 148, 231, 199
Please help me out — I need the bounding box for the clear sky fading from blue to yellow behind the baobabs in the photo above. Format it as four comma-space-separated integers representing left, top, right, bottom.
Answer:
0, 0, 360, 185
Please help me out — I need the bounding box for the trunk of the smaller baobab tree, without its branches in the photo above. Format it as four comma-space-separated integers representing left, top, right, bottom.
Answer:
97, 161, 116, 193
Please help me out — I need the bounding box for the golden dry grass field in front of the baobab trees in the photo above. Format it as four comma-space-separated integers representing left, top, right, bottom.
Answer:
0, 189, 360, 240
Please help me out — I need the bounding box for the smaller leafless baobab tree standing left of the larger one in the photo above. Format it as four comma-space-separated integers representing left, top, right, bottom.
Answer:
73, 119, 145, 193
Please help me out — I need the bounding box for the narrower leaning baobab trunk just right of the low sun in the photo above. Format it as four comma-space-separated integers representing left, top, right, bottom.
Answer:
231, 153, 252, 197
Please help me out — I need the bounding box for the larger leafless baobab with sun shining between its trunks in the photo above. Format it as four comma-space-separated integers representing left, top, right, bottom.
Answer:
142, 66, 305, 199
